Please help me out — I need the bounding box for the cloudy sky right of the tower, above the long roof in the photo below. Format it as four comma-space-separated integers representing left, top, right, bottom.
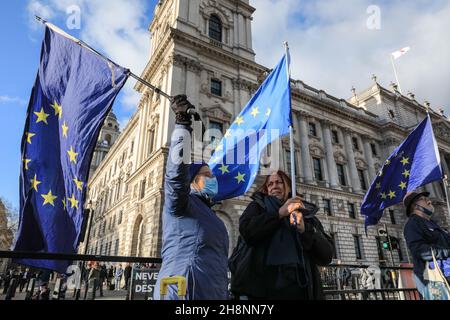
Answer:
251, 0, 450, 114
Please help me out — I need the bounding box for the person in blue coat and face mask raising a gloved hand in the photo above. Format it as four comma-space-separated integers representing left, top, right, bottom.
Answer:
154, 95, 229, 300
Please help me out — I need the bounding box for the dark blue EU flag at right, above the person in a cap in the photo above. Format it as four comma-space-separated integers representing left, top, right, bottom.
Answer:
361, 115, 443, 229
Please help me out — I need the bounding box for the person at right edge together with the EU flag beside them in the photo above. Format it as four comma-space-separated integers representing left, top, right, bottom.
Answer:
361, 114, 450, 295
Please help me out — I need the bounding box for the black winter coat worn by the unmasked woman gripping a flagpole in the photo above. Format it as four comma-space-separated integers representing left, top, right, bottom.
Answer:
231, 194, 334, 300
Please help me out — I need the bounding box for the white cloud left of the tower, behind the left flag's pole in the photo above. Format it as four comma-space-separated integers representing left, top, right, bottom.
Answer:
29, 0, 150, 113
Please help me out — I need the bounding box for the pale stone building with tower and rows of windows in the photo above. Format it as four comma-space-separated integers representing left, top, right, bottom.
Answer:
80, 0, 450, 264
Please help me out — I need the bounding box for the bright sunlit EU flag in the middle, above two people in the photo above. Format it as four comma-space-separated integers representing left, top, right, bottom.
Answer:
209, 54, 292, 201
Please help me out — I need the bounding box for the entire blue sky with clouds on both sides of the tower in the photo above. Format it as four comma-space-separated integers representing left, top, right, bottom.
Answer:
0, 0, 450, 212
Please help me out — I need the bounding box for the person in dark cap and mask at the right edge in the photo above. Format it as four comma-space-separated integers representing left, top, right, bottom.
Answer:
403, 191, 450, 298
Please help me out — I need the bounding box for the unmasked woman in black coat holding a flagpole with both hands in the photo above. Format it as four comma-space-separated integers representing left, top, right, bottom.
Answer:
231, 171, 334, 300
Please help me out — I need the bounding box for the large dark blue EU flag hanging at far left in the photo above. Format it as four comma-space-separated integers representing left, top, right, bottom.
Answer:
14, 26, 128, 273
